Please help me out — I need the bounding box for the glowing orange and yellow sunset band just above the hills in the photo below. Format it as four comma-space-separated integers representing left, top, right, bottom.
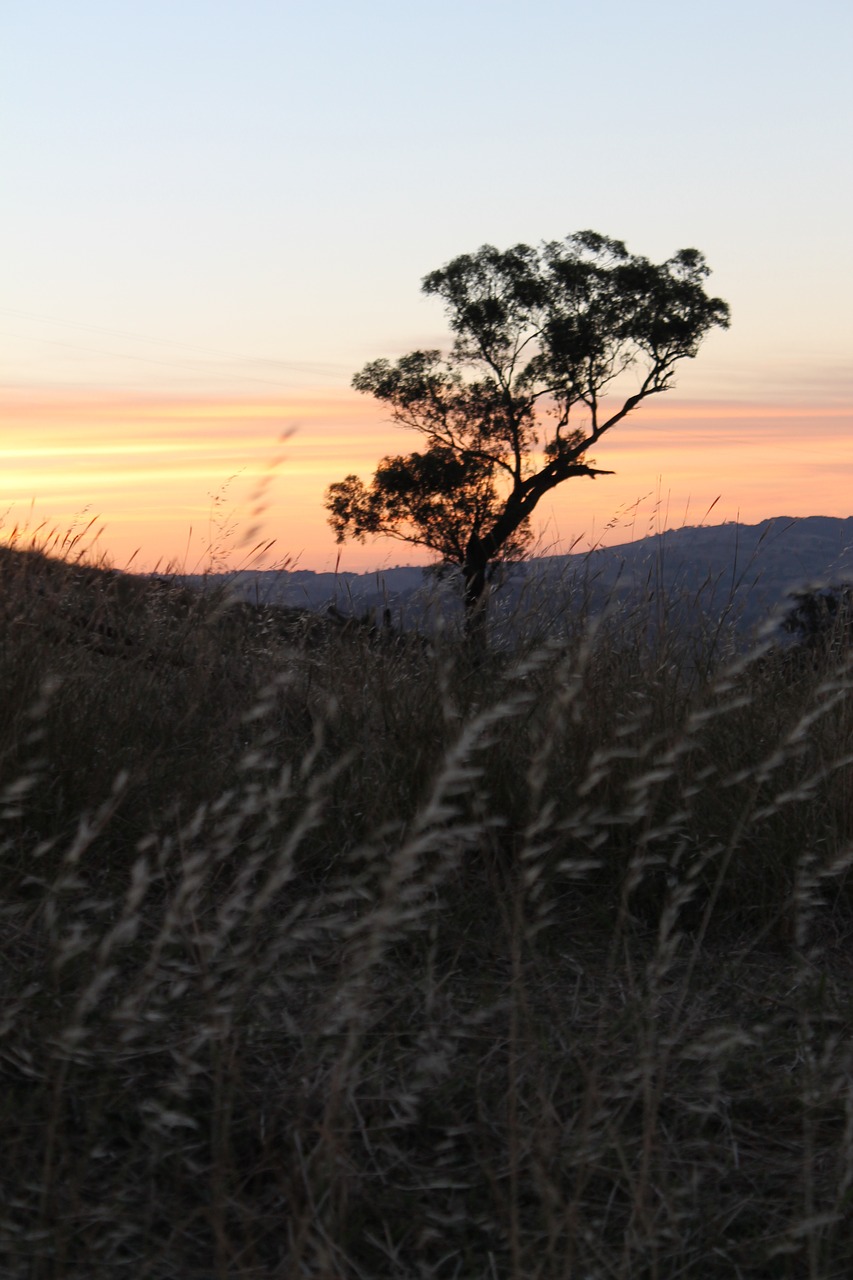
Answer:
0, 388, 853, 571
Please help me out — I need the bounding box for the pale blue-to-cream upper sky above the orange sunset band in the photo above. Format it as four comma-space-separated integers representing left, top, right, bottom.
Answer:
0, 0, 853, 392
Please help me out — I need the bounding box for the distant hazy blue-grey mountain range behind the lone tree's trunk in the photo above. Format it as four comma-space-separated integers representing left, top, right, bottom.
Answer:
172, 516, 853, 640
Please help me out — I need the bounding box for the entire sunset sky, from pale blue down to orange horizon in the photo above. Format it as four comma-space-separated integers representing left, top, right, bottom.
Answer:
0, 0, 853, 571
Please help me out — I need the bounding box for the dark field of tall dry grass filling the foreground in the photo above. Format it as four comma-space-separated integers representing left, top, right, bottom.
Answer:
0, 542, 853, 1280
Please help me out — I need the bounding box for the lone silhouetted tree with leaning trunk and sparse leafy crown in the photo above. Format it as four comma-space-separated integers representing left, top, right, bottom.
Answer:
325, 232, 729, 635
